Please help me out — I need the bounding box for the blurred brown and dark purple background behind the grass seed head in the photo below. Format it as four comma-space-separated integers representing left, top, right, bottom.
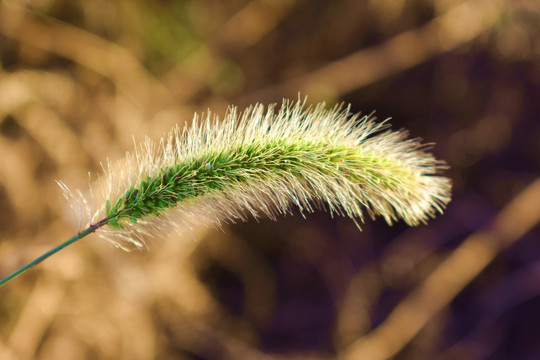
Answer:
0, 0, 540, 360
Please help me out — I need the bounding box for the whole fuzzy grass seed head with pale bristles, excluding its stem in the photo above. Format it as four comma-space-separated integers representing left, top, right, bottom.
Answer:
71, 101, 451, 248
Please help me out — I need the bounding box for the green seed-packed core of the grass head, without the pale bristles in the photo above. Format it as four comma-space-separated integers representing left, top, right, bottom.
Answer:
107, 140, 424, 228
